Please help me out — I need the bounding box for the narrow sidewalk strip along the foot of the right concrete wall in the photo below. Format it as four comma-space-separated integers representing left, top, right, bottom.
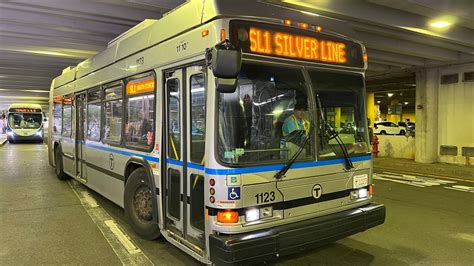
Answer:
373, 158, 474, 180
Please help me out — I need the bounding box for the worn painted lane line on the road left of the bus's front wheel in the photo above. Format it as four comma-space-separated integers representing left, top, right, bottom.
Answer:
69, 180, 154, 265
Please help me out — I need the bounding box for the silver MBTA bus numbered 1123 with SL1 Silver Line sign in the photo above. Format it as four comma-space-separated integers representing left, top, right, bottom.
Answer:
48, 0, 385, 265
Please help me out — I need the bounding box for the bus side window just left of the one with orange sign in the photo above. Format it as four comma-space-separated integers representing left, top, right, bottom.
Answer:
103, 84, 122, 144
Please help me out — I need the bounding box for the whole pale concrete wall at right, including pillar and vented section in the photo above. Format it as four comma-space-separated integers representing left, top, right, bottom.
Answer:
415, 63, 474, 164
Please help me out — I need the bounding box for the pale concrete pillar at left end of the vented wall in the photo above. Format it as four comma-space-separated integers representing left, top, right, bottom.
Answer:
415, 69, 439, 163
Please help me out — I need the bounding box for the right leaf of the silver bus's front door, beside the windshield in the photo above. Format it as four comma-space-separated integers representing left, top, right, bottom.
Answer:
185, 66, 206, 250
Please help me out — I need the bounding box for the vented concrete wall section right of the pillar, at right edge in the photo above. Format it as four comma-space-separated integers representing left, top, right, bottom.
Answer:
438, 64, 474, 164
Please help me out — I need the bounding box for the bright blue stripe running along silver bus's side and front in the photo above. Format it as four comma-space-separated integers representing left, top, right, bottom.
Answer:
81, 144, 371, 175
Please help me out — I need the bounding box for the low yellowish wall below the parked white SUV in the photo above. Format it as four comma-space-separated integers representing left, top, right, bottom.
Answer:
377, 135, 415, 159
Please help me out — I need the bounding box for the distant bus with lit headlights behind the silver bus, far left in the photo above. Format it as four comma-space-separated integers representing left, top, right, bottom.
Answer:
7, 103, 44, 143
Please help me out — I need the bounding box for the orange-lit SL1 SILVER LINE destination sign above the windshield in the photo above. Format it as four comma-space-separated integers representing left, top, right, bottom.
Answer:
231, 21, 364, 67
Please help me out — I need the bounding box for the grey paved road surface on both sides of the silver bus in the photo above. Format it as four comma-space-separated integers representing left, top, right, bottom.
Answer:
0, 144, 474, 265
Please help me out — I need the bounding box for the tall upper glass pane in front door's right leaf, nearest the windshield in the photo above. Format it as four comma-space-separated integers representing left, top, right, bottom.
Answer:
190, 74, 206, 165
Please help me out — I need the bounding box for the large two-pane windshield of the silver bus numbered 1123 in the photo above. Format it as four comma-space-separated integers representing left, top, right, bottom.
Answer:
217, 63, 369, 165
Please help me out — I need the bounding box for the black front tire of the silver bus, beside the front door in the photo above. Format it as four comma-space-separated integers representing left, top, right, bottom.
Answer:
124, 168, 161, 240
